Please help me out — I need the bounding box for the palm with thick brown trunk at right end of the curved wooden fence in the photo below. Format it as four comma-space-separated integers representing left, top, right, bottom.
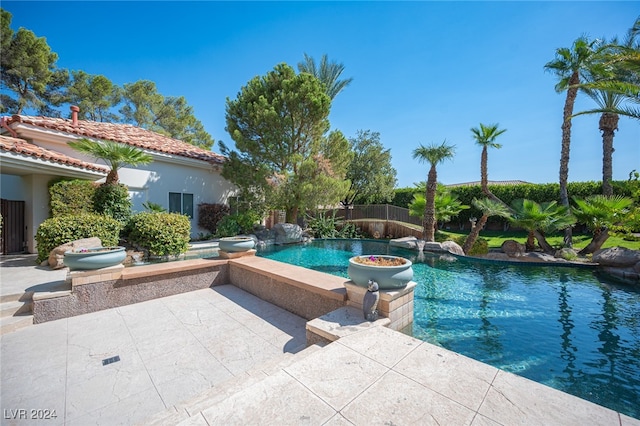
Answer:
413, 140, 455, 241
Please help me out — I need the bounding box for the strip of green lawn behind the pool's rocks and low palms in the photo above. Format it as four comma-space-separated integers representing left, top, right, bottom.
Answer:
438, 231, 640, 250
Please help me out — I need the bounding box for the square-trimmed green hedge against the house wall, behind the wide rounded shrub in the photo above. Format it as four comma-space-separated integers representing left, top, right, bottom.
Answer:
49, 179, 98, 217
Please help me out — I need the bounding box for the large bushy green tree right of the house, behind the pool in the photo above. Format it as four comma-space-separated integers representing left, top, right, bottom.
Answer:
220, 64, 351, 222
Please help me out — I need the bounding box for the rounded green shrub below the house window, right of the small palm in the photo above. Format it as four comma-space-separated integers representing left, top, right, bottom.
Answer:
127, 212, 191, 256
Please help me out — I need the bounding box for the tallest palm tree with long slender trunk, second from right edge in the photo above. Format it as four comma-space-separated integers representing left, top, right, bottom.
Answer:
544, 36, 599, 247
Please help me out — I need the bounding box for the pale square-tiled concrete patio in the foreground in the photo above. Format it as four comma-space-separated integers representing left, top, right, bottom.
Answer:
0, 255, 640, 425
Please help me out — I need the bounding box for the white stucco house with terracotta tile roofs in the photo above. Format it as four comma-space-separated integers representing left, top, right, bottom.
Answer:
0, 107, 234, 253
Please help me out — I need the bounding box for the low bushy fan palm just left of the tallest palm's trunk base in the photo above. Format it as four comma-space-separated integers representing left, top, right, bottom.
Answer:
510, 199, 576, 254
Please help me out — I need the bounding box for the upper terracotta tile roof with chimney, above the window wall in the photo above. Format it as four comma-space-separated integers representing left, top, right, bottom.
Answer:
7, 115, 225, 164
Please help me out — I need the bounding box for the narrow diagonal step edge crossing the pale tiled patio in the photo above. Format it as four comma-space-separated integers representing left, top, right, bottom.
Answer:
143, 344, 323, 425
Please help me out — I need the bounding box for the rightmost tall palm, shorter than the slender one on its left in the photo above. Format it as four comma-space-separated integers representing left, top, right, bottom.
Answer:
576, 88, 625, 195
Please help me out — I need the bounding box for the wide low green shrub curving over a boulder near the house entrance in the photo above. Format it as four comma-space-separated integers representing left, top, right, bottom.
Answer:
36, 213, 122, 262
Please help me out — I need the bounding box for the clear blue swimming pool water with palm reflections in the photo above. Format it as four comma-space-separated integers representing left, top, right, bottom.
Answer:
258, 240, 640, 418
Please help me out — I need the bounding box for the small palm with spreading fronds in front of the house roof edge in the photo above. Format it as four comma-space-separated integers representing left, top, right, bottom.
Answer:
67, 139, 153, 185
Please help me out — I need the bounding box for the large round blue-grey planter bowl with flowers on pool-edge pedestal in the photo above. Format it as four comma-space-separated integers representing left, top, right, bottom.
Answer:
347, 255, 413, 290
